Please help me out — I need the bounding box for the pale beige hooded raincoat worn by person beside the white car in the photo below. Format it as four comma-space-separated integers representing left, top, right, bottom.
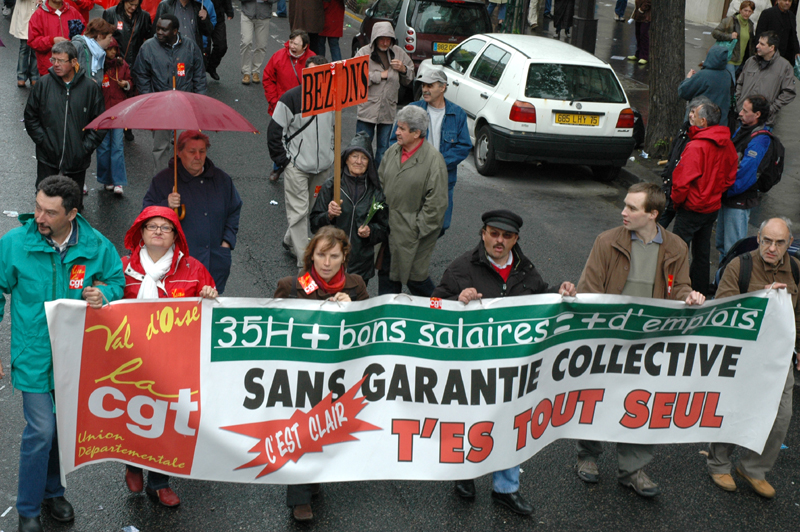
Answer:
356, 22, 416, 124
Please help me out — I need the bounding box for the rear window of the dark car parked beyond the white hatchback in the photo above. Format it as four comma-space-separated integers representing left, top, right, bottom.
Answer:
412, 0, 492, 36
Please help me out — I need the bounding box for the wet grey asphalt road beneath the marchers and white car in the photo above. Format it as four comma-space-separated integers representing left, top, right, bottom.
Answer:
0, 4, 800, 532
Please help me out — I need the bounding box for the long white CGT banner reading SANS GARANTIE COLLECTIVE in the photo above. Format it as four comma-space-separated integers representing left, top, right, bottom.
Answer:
45, 290, 795, 484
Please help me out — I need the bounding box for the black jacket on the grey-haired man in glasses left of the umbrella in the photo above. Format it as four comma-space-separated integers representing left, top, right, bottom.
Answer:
24, 67, 106, 173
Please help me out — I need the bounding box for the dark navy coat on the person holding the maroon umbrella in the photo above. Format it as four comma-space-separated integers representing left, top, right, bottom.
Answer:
142, 158, 242, 294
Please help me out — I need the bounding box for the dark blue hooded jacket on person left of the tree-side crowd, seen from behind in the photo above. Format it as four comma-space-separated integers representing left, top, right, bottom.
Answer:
678, 46, 733, 126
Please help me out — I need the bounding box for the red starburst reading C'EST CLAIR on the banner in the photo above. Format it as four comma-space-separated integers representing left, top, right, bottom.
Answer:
221, 376, 382, 478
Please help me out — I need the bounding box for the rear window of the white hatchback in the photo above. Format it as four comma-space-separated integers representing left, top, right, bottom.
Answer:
525, 63, 625, 103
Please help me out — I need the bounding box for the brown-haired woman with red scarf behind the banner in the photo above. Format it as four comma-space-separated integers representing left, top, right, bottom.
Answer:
274, 225, 369, 521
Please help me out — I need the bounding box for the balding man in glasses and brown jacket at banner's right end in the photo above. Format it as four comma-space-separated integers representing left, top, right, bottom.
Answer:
707, 218, 800, 499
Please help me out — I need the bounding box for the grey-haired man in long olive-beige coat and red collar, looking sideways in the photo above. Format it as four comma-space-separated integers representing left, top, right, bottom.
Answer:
378, 106, 447, 297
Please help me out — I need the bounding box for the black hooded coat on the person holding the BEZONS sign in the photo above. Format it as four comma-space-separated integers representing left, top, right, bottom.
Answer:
309, 143, 389, 281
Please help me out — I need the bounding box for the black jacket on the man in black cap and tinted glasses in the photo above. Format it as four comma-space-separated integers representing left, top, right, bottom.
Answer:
432, 240, 558, 300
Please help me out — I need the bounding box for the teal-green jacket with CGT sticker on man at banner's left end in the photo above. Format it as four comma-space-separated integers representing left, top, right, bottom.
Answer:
0, 214, 125, 393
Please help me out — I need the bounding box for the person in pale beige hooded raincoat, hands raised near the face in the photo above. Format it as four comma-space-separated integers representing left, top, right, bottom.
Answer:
356, 22, 414, 166
